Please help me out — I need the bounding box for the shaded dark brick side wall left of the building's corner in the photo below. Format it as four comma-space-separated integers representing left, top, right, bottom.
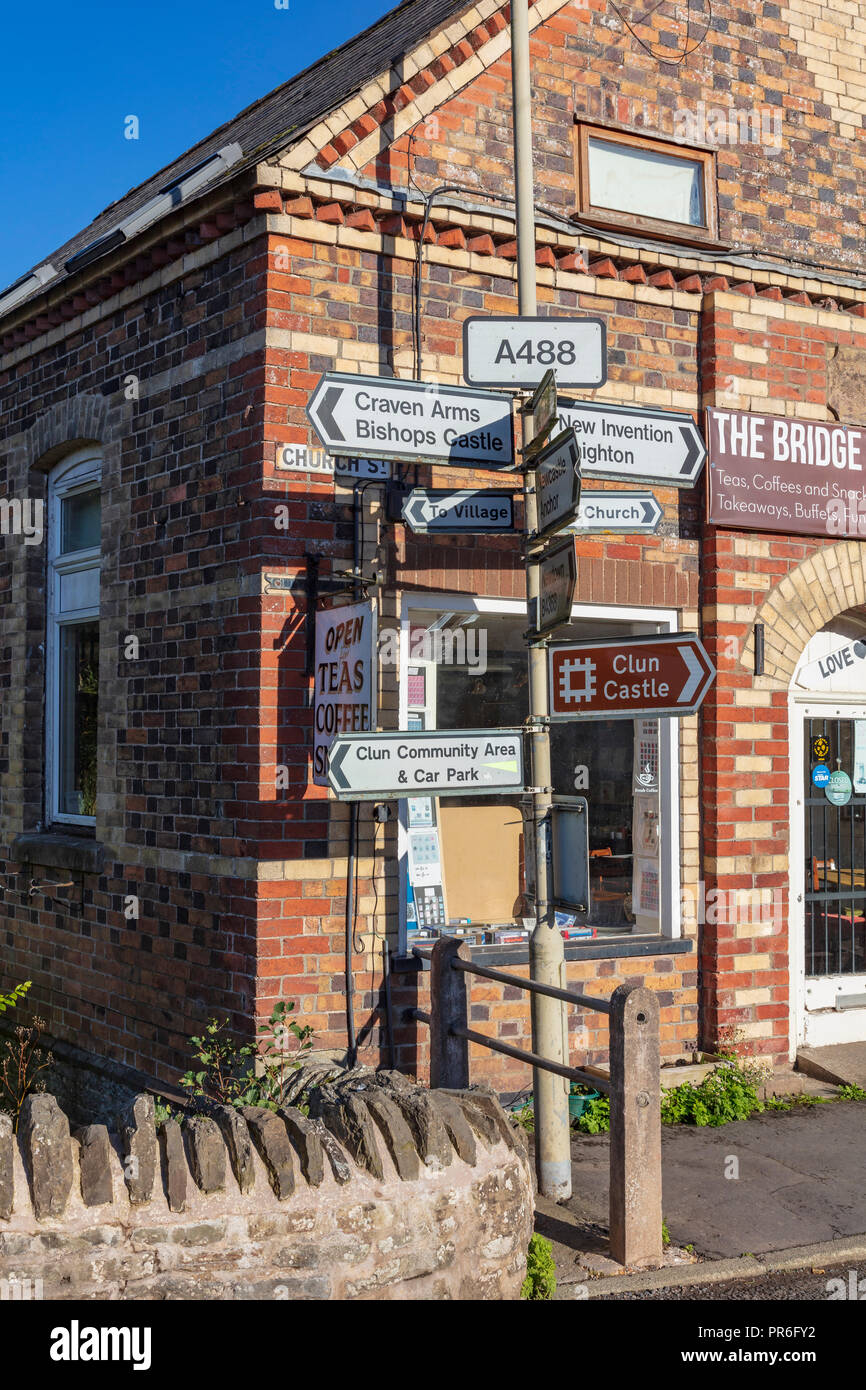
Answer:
0, 227, 272, 1077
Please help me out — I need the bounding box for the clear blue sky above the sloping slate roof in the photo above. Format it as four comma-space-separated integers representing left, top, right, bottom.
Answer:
0, 0, 396, 289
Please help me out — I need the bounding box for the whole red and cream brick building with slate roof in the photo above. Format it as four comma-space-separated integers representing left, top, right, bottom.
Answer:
0, 0, 866, 1106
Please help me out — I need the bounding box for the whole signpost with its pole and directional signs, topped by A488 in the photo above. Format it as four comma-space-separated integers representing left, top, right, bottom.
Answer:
301, 0, 695, 1201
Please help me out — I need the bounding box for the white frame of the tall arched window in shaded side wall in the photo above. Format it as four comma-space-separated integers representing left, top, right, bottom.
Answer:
44, 446, 101, 826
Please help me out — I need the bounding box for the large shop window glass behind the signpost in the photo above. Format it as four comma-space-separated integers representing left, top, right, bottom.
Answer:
400, 600, 677, 947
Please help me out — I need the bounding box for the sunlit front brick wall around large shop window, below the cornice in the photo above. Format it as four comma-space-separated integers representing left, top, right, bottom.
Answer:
257, 214, 699, 1067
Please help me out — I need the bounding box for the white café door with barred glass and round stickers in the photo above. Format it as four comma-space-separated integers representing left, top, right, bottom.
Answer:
790, 696, 866, 1047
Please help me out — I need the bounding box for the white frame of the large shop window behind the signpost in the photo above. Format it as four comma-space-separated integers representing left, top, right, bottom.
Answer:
398, 591, 683, 951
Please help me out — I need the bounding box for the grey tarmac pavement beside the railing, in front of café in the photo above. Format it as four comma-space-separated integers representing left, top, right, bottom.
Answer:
537, 1101, 866, 1297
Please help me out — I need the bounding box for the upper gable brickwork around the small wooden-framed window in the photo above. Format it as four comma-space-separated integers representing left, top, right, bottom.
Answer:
355, 0, 865, 271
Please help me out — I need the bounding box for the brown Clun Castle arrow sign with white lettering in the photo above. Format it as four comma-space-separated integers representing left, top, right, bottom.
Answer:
548, 632, 716, 720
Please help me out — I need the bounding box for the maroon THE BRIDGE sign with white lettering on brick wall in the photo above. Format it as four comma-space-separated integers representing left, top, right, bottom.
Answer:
706, 410, 866, 537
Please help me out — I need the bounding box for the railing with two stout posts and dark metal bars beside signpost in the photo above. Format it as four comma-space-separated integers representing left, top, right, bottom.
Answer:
413, 937, 662, 1266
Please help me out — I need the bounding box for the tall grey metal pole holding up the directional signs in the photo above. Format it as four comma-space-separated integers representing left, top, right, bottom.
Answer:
512, 0, 571, 1201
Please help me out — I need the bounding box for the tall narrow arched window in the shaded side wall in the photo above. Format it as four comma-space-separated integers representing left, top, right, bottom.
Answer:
46, 450, 101, 826
